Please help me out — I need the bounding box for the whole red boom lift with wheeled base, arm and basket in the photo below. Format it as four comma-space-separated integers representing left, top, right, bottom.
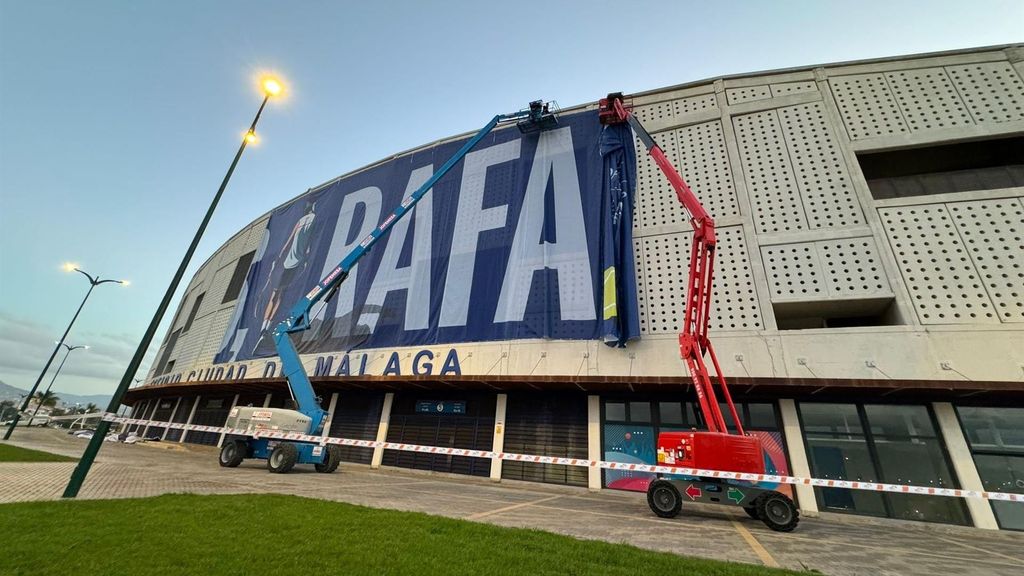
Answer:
598, 92, 800, 532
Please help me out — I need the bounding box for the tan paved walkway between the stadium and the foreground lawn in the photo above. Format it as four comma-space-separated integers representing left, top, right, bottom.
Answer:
0, 429, 1024, 576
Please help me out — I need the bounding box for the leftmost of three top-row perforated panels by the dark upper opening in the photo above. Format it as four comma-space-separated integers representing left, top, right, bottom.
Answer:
828, 74, 907, 140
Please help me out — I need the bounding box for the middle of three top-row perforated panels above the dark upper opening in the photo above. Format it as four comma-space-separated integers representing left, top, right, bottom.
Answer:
886, 68, 973, 131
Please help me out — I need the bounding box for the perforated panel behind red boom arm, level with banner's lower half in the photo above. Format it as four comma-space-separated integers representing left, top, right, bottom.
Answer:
641, 227, 762, 334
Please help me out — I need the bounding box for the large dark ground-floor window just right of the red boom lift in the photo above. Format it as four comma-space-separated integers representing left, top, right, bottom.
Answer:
800, 402, 967, 524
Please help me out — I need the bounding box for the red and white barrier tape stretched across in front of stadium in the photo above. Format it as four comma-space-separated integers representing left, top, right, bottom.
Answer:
103, 413, 1024, 502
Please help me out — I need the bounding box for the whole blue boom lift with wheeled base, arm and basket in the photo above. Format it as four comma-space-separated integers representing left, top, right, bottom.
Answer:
220, 100, 558, 474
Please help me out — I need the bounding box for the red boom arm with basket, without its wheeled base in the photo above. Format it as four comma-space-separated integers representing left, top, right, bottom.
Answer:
598, 92, 743, 435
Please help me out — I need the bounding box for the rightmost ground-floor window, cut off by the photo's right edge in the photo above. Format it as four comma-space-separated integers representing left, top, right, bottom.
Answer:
956, 406, 1024, 530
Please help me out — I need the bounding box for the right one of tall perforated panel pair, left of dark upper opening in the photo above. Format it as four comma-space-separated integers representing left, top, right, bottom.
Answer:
778, 102, 864, 229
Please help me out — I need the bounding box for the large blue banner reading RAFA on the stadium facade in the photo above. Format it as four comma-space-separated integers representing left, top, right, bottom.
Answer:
215, 112, 639, 363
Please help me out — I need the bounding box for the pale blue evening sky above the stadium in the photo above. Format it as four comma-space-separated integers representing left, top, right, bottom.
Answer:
0, 0, 1024, 394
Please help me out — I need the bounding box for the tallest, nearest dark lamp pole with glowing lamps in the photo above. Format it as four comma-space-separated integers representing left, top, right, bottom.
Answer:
63, 78, 283, 498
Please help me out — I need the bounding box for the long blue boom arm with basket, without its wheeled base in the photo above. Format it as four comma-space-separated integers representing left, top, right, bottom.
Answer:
273, 100, 557, 433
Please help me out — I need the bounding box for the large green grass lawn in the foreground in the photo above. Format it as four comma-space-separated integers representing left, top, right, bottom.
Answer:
0, 494, 795, 576
